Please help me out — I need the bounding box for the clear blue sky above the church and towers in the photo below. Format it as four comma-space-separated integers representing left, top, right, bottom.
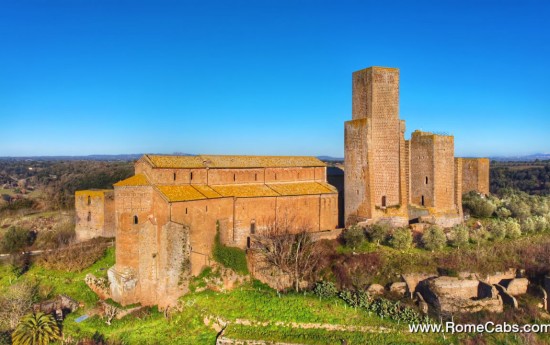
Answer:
0, 0, 550, 157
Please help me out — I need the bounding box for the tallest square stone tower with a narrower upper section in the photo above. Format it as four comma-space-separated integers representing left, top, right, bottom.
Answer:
344, 67, 409, 225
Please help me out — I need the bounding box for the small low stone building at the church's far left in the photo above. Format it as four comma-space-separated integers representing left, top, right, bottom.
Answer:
75, 189, 115, 241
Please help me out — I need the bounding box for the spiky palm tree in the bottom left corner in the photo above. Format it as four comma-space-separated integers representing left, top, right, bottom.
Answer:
12, 312, 61, 345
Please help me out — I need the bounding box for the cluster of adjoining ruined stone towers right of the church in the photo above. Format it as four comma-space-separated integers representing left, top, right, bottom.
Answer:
344, 67, 489, 226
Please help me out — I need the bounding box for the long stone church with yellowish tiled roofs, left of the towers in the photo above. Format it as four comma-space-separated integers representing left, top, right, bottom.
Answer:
97, 155, 338, 307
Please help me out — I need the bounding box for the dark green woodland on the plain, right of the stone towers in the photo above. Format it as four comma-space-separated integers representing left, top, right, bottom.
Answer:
490, 161, 550, 195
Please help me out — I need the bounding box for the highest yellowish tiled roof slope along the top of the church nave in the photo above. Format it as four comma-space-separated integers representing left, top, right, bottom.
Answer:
145, 155, 326, 169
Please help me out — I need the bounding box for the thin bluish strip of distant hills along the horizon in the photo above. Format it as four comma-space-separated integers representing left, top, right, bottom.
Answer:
0, 152, 550, 162
